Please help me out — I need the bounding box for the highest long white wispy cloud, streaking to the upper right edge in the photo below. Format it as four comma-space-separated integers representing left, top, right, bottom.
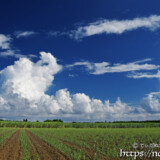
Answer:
68, 15, 160, 40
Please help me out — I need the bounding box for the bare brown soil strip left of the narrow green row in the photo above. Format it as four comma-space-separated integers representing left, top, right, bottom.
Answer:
0, 129, 22, 160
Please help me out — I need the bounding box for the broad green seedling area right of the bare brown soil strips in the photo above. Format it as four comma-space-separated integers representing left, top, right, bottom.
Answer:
30, 128, 160, 160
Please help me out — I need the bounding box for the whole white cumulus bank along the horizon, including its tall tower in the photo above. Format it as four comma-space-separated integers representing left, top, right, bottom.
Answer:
0, 52, 160, 120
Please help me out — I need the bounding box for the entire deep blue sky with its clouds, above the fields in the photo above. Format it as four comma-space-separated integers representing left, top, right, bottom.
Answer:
0, 0, 160, 121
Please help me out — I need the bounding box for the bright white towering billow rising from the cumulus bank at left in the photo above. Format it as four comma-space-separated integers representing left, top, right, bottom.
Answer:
0, 52, 62, 100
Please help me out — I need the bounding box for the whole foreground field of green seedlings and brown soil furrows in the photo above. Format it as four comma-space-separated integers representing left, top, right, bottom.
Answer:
0, 128, 160, 160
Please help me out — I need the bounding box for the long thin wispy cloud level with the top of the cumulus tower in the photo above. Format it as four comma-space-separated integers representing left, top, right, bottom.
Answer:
66, 58, 160, 75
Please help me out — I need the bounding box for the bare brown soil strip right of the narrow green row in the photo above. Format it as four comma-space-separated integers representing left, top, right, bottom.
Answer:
25, 130, 71, 160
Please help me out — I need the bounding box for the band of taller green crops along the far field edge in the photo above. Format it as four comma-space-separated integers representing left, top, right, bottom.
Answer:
0, 121, 160, 128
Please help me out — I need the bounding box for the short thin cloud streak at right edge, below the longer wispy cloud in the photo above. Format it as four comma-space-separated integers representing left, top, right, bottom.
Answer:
127, 70, 160, 79
